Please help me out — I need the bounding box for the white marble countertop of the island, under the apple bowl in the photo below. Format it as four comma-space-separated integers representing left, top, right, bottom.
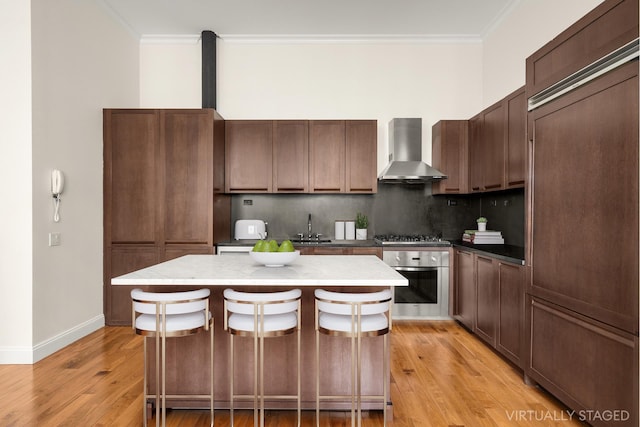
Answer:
111, 255, 408, 287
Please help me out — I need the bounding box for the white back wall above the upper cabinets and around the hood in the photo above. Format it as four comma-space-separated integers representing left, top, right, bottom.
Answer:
140, 40, 482, 170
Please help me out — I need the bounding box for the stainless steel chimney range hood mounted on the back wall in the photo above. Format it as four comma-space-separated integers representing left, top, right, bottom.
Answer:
378, 118, 447, 184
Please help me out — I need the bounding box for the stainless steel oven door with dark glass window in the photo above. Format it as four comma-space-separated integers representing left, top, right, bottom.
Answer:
393, 267, 449, 319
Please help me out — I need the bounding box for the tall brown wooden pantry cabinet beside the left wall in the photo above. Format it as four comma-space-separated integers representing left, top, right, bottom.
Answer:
103, 109, 230, 325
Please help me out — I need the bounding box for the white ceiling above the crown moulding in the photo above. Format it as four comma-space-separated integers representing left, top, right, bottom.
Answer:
98, 0, 520, 39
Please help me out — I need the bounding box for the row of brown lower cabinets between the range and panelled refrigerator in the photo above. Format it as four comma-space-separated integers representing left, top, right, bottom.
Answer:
454, 249, 524, 367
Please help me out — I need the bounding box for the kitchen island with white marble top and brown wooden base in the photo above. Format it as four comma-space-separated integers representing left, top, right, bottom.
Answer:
111, 255, 408, 413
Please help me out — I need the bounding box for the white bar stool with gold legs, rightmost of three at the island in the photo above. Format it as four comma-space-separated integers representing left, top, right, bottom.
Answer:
315, 289, 391, 426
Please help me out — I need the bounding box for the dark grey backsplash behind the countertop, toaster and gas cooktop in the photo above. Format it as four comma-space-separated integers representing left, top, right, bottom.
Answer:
231, 184, 524, 246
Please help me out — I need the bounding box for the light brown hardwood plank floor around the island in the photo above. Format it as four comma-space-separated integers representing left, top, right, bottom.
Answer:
0, 321, 582, 427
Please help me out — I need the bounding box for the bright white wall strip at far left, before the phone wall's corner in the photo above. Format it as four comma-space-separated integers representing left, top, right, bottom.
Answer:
0, 0, 33, 363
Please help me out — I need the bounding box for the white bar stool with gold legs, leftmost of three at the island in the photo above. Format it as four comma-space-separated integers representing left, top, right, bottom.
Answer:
131, 289, 214, 427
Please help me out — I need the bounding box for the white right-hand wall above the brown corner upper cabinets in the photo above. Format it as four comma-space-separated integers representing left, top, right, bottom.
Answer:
482, 0, 602, 108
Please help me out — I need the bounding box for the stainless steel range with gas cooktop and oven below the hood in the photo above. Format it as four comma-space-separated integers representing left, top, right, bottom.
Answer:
374, 235, 451, 319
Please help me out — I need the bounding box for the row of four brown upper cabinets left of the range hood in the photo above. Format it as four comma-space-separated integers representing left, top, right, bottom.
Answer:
226, 120, 377, 193
